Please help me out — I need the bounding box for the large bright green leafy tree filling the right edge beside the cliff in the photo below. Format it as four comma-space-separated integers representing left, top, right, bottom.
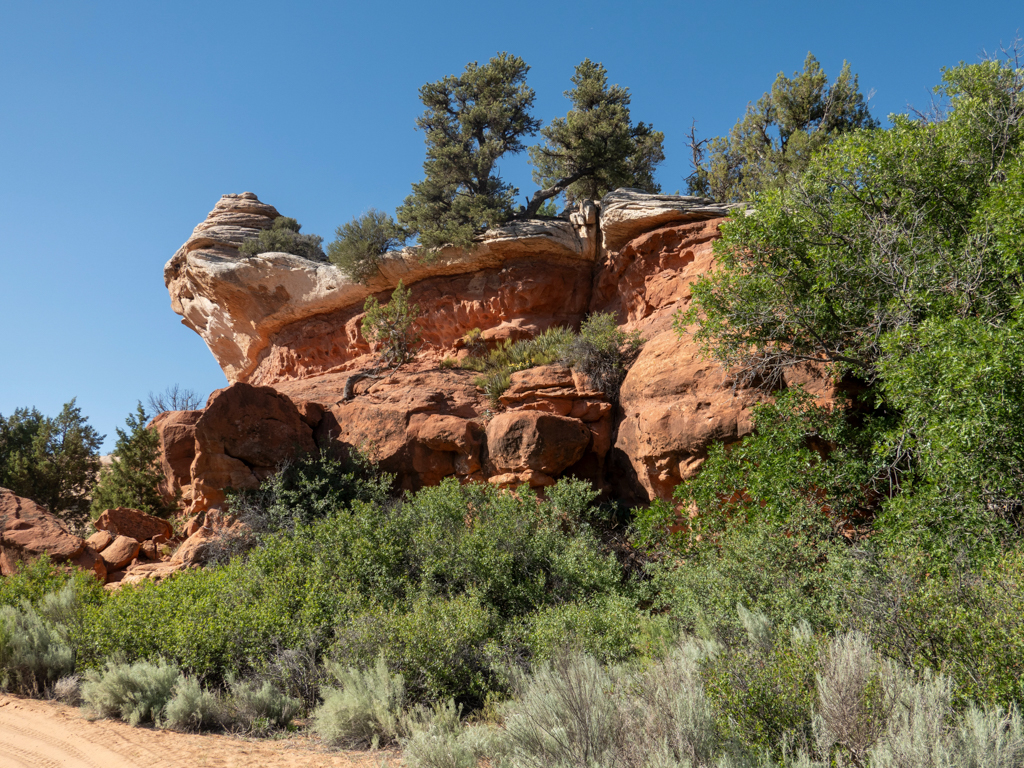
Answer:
676, 55, 1024, 551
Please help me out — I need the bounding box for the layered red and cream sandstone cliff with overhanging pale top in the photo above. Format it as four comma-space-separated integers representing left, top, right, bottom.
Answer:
158, 189, 823, 510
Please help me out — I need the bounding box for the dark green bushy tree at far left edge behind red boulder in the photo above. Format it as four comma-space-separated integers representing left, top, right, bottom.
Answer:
0, 399, 103, 525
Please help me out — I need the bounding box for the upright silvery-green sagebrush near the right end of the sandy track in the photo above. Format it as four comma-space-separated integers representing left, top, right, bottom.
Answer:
312, 656, 407, 750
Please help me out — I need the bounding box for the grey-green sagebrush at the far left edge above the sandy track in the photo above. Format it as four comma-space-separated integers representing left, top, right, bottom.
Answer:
0, 588, 75, 695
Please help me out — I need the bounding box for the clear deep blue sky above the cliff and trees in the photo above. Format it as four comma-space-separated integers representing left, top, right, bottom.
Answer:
0, 0, 1024, 451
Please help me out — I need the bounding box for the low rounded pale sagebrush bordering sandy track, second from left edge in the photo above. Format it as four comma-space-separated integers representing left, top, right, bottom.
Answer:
82, 659, 180, 725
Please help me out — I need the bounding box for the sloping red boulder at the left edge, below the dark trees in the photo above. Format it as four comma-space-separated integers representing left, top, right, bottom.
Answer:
0, 488, 85, 575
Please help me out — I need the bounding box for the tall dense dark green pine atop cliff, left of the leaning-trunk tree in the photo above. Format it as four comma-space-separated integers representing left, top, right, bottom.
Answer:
397, 53, 541, 249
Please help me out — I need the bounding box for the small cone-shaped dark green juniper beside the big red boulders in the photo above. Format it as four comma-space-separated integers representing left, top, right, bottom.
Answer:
92, 402, 176, 516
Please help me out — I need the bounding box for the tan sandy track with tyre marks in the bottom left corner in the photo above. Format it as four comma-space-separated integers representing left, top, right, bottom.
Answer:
0, 695, 401, 768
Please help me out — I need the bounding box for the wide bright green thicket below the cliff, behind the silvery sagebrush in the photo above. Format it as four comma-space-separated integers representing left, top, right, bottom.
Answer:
75, 478, 628, 703
